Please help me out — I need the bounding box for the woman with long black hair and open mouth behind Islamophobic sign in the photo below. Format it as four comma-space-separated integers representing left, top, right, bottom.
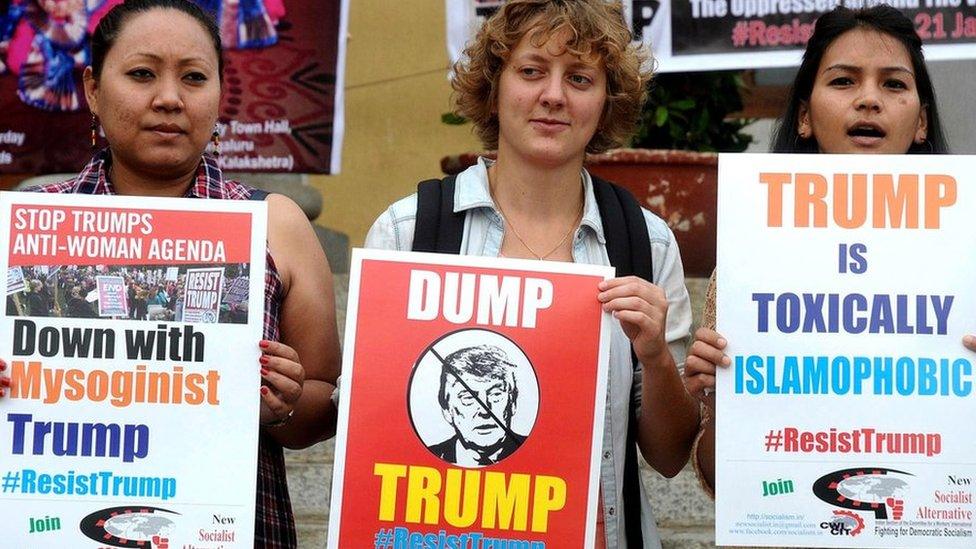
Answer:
684, 5, 948, 494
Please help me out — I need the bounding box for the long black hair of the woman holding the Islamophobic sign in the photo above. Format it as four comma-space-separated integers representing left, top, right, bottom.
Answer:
770, 4, 949, 153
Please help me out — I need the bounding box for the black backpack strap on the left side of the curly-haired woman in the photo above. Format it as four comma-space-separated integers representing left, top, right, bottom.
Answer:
411, 175, 465, 254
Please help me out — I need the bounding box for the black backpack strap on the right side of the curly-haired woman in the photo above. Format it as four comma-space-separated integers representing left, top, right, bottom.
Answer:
590, 175, 654, 549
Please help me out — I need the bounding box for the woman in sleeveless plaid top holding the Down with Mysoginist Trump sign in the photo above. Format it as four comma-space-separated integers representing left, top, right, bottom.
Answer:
0, 0, 339, 547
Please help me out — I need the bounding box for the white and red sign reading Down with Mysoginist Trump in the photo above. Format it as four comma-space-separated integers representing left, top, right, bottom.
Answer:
0, 193, 267, 549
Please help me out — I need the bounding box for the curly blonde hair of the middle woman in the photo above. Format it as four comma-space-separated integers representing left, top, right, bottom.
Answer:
451, 0, 651, 153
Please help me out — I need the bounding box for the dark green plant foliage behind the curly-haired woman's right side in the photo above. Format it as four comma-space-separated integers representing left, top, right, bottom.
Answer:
630, 71, 752, 152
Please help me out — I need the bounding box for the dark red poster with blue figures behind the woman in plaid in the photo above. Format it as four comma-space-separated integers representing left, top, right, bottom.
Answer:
0, 0, 348, 174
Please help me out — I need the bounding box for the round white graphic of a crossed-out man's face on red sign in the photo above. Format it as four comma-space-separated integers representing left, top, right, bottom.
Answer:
410, 330, 539, 467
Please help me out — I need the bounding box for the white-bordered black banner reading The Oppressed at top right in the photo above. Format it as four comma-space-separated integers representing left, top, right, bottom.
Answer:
445, 0, 976, 72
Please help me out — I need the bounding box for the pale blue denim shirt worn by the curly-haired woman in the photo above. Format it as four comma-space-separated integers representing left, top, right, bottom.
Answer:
366, 159, 691, 549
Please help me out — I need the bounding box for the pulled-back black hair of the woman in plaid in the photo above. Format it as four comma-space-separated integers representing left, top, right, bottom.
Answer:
91, 0, 224, 81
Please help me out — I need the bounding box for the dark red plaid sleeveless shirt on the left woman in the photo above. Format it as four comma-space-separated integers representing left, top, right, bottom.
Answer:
29, 149, 297, 548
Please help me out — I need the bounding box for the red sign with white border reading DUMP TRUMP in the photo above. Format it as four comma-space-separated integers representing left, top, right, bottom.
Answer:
329, 250, 613, 549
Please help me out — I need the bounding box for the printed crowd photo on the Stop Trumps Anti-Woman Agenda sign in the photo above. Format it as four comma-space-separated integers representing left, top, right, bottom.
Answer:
6, 263, 251, 324
